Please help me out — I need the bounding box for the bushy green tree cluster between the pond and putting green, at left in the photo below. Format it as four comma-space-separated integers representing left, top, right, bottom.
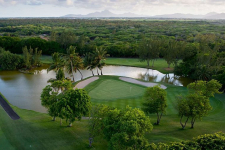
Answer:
41, 80, 91, 126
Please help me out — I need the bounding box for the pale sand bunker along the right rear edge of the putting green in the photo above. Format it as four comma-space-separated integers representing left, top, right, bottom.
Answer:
119, 77, 167, 89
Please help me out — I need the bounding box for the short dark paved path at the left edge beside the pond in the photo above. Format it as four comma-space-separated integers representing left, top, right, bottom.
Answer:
0, 95, 20, 120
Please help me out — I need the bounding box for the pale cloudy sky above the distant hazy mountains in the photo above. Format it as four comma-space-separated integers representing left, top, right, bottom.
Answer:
0, 0, 225, 17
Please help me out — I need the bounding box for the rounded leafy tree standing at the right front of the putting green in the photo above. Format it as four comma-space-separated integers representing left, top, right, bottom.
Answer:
142, 85, 167, 125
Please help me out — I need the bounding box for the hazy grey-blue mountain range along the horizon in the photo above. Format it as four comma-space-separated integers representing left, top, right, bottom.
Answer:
62, 10, 225, 19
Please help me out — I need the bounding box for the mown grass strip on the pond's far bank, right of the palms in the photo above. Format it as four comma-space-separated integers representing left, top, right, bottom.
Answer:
106, 58, 174, 74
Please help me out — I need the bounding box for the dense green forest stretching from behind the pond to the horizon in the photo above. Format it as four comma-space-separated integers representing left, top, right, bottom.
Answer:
0, 19, 225, 57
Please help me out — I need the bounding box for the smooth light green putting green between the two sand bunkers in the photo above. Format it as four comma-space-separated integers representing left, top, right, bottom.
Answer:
89, 79, 145, 100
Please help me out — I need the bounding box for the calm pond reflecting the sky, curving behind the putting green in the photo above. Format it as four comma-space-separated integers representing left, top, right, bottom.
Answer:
0, 65, 192, 113
